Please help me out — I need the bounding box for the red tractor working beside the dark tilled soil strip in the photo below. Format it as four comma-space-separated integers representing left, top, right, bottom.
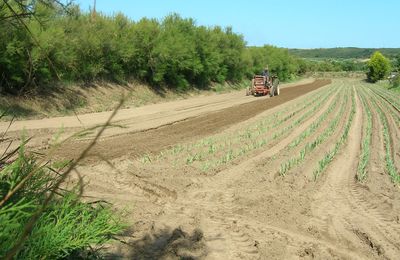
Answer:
246, 75, 280, 97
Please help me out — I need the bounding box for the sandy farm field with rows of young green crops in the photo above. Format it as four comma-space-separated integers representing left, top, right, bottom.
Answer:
0, 79, 400, 259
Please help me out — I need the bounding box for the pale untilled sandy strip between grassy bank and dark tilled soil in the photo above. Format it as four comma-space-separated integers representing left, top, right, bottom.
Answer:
0, 79, 314, 152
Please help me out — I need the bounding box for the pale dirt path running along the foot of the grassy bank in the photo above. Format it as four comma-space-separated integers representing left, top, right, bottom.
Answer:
0, 79, 314, 135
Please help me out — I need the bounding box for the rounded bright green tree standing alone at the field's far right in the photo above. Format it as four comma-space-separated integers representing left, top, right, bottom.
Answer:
367, 51, 391, 83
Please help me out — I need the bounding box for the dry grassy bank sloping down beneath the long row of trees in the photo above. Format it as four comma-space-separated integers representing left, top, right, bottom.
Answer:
0, 81, 247, 120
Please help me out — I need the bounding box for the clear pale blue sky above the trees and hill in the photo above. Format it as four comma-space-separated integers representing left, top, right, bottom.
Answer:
75, 0, 400, 48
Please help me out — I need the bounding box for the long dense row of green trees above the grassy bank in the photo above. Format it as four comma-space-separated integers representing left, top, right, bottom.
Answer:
0, 1, 303, 94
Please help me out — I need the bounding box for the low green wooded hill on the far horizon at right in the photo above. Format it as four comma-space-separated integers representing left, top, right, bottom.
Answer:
289, 47, 400, 59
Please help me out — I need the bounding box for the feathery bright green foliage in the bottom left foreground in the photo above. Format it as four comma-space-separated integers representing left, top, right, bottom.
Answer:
0, 145, 122, 259
